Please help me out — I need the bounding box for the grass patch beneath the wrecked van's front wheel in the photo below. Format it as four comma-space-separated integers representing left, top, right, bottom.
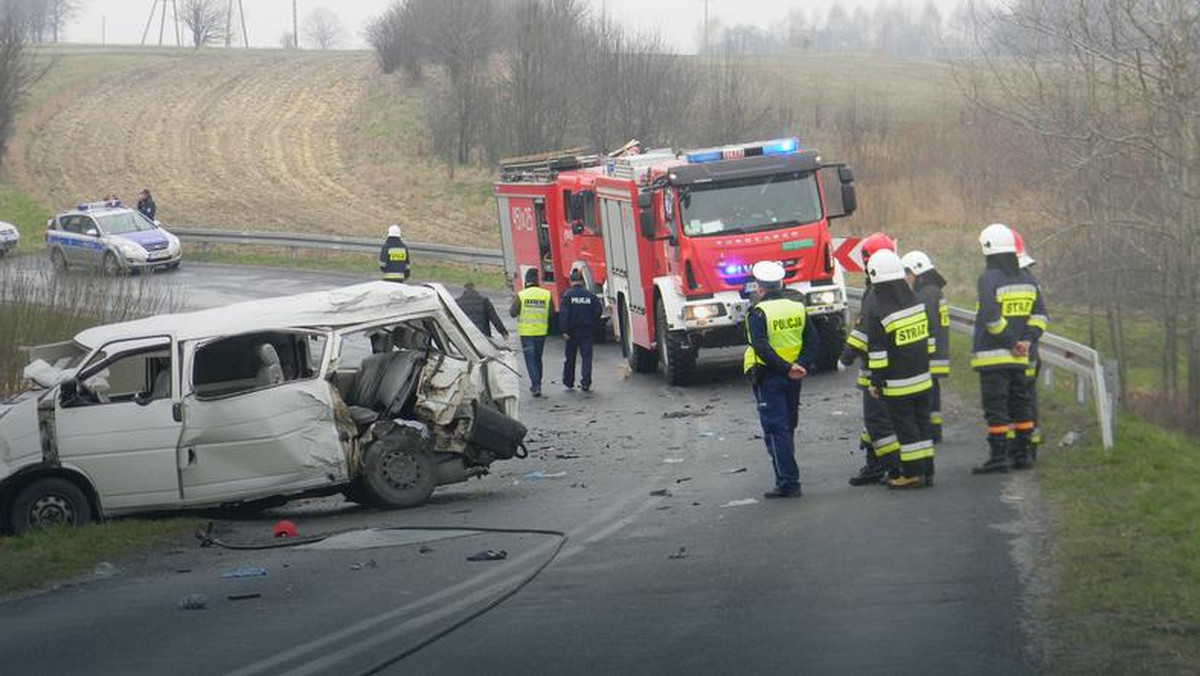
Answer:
0, 519, 199, 594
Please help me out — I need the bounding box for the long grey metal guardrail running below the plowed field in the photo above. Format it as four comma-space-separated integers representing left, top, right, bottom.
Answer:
170, 228, 504, 265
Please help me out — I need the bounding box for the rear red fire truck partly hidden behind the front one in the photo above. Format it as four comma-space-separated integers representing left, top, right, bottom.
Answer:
493, 149, 610, 337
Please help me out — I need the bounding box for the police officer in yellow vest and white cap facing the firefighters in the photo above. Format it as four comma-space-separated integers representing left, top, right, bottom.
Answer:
743, 261, 818, 498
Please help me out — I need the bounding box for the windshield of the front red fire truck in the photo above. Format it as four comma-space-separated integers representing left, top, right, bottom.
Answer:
679, 172, 821, 237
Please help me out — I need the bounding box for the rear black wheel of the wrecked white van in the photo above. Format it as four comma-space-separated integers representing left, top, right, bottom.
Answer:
361, 426, 438, 509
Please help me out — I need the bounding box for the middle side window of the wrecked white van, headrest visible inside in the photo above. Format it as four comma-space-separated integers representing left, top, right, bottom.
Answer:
192, 331, 326, 399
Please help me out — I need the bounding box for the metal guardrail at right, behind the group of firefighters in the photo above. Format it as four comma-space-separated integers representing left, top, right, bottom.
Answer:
846, 288, 1114, 449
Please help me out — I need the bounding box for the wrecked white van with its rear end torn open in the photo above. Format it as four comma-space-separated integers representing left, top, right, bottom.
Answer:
0, 282, 526, 532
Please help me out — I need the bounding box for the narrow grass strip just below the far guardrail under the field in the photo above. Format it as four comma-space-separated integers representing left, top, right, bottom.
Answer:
185, 246, 508, 291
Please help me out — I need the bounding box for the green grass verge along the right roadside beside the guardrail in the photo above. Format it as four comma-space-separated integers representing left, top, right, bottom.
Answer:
950, 335, 1200, 674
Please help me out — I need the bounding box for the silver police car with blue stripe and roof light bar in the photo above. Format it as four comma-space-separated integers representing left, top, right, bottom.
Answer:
46, 201, 184, 275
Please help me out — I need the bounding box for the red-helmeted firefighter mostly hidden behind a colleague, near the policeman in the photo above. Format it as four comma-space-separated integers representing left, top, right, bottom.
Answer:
841, 233, 900, 486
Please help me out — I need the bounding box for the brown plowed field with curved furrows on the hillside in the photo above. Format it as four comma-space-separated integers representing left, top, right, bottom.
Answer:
5, 50, 498, 246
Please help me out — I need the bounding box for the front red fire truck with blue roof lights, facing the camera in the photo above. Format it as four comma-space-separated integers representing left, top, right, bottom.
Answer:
595, 138, 857, 384
